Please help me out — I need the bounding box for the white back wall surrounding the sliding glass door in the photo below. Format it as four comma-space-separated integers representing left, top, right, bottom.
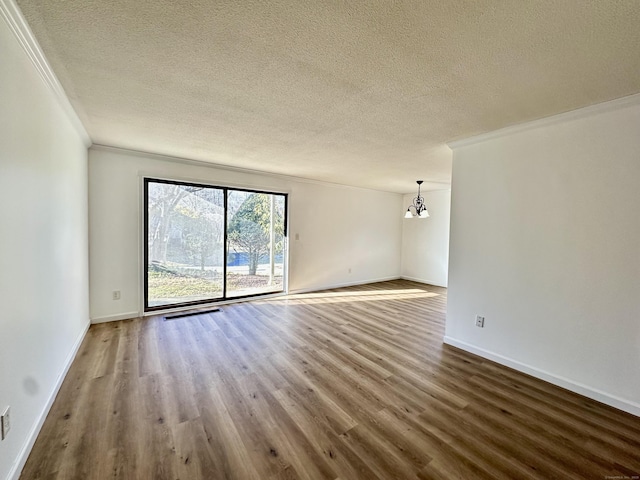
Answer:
89, 147, 403, 322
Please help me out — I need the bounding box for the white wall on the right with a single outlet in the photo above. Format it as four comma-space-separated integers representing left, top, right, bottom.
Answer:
446, 96, 640, 415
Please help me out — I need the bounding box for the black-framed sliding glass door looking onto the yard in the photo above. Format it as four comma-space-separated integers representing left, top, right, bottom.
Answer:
144, 179, 287, 311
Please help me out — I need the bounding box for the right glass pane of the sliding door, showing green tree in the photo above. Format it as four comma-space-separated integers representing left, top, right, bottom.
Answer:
227, 190, 285, 297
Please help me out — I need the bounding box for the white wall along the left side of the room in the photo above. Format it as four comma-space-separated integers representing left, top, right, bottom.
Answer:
0, 11, 89, 479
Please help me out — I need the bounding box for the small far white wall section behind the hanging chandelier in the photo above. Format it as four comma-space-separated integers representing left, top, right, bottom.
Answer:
401, 190, 451, 287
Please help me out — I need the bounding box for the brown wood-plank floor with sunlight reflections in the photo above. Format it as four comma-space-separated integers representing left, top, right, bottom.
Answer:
21, 281, 640, 480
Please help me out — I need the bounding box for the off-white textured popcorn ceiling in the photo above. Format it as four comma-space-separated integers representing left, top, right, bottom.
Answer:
17, 0, 640, 193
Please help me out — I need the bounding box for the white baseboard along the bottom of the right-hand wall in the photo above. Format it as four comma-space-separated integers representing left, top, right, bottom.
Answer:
444, 336, 640, 417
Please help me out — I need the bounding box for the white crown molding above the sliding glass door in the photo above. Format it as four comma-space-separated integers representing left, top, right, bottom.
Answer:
92, 142, 402, 195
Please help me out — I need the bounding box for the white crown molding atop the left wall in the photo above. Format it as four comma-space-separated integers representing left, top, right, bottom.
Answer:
0, 0, 92, 148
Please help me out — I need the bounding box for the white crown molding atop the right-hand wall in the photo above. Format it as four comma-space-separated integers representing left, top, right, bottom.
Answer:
447, 93, 640, 150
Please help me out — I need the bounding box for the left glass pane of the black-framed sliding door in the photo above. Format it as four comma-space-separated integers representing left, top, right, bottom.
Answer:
147, 181, 224, 307
